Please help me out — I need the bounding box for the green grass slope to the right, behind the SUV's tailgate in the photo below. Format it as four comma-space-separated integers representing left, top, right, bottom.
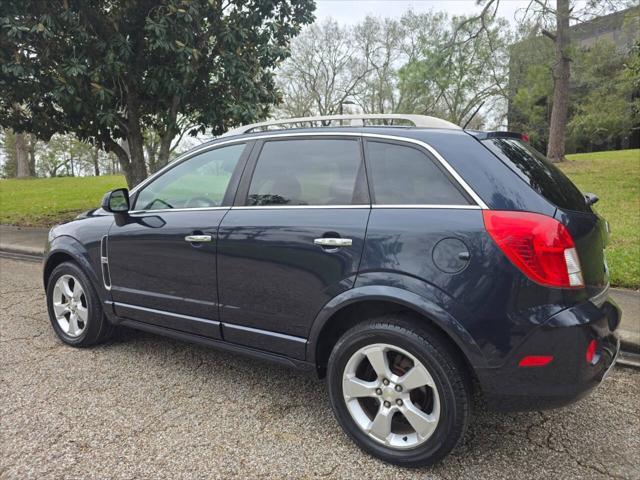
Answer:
560, 149, 640, 289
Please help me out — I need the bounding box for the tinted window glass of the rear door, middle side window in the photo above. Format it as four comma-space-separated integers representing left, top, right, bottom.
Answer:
247, 139, 369, 206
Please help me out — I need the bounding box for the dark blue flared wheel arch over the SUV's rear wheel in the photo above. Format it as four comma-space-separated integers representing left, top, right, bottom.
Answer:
307, 286, 485, 377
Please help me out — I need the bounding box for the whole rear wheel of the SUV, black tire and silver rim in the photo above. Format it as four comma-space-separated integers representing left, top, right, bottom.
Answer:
327, 316, 471, 467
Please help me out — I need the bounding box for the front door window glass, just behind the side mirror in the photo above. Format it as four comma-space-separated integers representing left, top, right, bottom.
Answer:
134, 143, 245, 210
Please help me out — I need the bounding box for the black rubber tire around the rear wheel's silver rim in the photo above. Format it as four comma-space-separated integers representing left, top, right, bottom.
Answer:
327, 315, 472, 467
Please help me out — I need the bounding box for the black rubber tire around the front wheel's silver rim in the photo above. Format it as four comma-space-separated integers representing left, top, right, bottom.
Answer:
47, 262, 114, 348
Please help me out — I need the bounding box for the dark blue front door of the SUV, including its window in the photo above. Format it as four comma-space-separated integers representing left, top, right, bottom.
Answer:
107, 143, 251, 338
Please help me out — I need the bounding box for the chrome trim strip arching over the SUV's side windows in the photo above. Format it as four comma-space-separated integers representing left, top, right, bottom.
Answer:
131, 132, 489, 209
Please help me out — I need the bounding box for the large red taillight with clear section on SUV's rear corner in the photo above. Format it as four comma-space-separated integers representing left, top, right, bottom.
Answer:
483, 210, 584, 288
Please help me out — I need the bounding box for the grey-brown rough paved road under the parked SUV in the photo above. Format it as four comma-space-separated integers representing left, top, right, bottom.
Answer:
0, 259, 640, 480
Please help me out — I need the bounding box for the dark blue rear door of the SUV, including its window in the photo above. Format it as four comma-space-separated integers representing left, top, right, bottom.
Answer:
218, 137, 370, 358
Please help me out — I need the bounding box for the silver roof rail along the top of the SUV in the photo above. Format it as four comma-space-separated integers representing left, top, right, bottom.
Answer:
222, 113, 461, 137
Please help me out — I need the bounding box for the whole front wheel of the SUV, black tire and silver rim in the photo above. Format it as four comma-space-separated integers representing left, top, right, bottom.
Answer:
47, 262, 114, 347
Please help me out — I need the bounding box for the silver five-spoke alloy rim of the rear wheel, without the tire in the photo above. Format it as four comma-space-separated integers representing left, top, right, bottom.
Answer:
342, 343, 440, 449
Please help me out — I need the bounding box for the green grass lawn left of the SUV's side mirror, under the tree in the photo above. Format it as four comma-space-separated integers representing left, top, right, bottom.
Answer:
0, 176, 127, 227
